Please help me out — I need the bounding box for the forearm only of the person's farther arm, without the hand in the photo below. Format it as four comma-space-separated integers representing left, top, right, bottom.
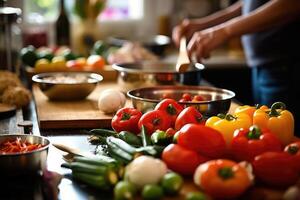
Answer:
191, 1, 242, 28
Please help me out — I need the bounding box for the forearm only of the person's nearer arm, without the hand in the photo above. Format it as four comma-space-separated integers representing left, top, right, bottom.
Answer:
222, 0, 300, 37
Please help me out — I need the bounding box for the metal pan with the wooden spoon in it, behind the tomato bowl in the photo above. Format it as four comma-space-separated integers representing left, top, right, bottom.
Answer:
112, 61, 204, 92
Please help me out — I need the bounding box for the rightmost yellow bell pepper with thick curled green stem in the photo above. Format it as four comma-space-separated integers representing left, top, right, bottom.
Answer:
253, 102, 294, 145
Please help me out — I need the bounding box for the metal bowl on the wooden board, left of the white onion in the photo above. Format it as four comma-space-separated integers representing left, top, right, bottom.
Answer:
32, 72, 103, 101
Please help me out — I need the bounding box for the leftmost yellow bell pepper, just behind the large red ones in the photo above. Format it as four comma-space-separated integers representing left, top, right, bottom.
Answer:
205, 113, 252, 145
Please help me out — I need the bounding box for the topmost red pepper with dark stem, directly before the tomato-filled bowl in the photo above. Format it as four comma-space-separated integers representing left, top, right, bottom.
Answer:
154, 99, 183, 126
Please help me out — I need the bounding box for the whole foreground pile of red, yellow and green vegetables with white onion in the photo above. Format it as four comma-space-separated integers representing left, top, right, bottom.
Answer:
61, 99, 300, 199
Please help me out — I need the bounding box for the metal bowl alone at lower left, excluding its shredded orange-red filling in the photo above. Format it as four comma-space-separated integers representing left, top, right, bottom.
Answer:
0, 134, 50, 176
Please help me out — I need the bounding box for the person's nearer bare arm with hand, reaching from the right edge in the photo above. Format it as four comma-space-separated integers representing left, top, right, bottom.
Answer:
188, 0, 300, 62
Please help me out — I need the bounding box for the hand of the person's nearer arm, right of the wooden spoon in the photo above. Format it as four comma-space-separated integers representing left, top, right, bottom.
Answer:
187, 26, 229, 63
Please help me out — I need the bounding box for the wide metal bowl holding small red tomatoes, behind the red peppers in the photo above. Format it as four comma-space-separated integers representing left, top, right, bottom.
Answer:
127, 86, 235, 117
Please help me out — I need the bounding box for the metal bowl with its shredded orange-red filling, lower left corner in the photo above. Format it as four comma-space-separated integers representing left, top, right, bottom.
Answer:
0, 134, 50, 176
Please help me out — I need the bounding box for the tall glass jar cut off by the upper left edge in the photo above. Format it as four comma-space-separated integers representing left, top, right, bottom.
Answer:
0, 7, 22, 73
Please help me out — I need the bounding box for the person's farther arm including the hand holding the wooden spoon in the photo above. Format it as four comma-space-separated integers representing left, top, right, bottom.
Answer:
172, 1, 242, 46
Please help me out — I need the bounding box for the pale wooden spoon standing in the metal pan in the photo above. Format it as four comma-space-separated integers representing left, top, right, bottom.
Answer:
176, 37, 191, 73
